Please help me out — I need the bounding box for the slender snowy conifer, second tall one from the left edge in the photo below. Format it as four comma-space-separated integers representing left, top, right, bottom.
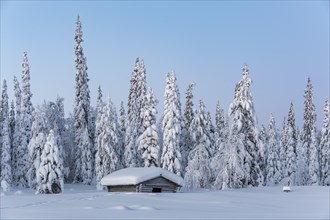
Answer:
12, 76, 22, 185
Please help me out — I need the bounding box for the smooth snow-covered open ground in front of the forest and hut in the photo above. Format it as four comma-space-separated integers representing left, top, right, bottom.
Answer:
0, 185, 330, 219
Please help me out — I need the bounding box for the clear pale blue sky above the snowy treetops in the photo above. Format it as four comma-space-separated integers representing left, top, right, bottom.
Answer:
0, 0, 329, 128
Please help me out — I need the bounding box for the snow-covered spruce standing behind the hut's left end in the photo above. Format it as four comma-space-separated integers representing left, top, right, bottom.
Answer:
96, 98, 119, 190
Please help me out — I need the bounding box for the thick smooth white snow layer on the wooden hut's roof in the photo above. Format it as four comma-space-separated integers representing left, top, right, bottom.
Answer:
101, 167, 184, 186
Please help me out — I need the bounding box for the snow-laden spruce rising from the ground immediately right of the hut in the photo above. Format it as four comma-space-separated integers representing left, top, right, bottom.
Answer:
184, 100, 212, 189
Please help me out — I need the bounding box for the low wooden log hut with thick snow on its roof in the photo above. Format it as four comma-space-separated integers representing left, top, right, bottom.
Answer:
101, 167, 184, 193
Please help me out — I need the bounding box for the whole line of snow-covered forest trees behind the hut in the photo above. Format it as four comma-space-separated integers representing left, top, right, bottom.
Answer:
0, 17, 330, 193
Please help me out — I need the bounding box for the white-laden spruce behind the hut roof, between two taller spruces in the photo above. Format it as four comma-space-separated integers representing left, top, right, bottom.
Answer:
138, 88, 159, 167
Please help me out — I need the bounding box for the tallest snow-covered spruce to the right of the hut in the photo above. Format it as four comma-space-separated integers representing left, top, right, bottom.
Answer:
229, 65, 263, 186
